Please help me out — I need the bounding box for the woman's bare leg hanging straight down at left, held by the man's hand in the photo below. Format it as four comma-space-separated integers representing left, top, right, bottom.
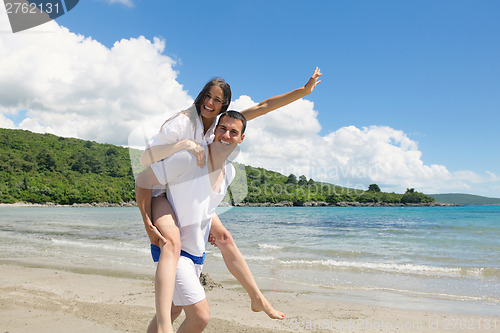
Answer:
152, 196, 181, 333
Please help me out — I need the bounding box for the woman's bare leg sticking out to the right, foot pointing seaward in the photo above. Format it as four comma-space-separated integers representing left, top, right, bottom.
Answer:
210, 214, 285, 319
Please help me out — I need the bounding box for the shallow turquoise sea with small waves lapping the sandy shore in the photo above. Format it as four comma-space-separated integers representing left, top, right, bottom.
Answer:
0, 206, 500, 315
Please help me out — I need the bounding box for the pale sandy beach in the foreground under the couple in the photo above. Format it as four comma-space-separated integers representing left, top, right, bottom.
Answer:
0, 264, 500, 333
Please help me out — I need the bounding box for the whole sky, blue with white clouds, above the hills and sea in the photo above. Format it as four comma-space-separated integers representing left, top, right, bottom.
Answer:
0, 0, 500, 197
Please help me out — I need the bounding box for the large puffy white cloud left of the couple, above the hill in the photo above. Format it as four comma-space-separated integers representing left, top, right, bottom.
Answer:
0, 11, 192, 144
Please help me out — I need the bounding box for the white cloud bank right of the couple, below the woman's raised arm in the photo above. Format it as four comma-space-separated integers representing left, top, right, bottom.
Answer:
230, 96, 498, 193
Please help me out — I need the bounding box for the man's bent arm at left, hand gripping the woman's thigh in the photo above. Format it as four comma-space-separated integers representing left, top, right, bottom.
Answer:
135, 168, 167, 246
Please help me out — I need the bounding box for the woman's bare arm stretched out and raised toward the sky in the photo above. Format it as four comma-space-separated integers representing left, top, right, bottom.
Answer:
241, 67, 323, 120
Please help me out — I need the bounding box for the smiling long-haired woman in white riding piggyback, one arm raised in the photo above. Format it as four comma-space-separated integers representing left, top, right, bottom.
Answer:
136, 68, 322, 331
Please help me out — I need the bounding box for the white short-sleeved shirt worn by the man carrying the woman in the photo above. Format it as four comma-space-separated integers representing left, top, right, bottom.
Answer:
151, 150, 235, 257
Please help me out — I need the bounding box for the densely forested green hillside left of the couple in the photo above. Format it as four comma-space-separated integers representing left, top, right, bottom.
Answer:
0, 129, 135, 204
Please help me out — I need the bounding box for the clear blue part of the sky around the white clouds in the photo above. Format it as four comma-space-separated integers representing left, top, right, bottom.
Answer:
0, 0, 500, 197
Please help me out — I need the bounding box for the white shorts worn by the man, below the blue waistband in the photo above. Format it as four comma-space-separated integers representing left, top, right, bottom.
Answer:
173, 256, 206, 306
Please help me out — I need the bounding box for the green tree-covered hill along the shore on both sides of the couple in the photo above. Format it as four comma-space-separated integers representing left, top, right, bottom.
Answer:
0, 129, 434, 205
